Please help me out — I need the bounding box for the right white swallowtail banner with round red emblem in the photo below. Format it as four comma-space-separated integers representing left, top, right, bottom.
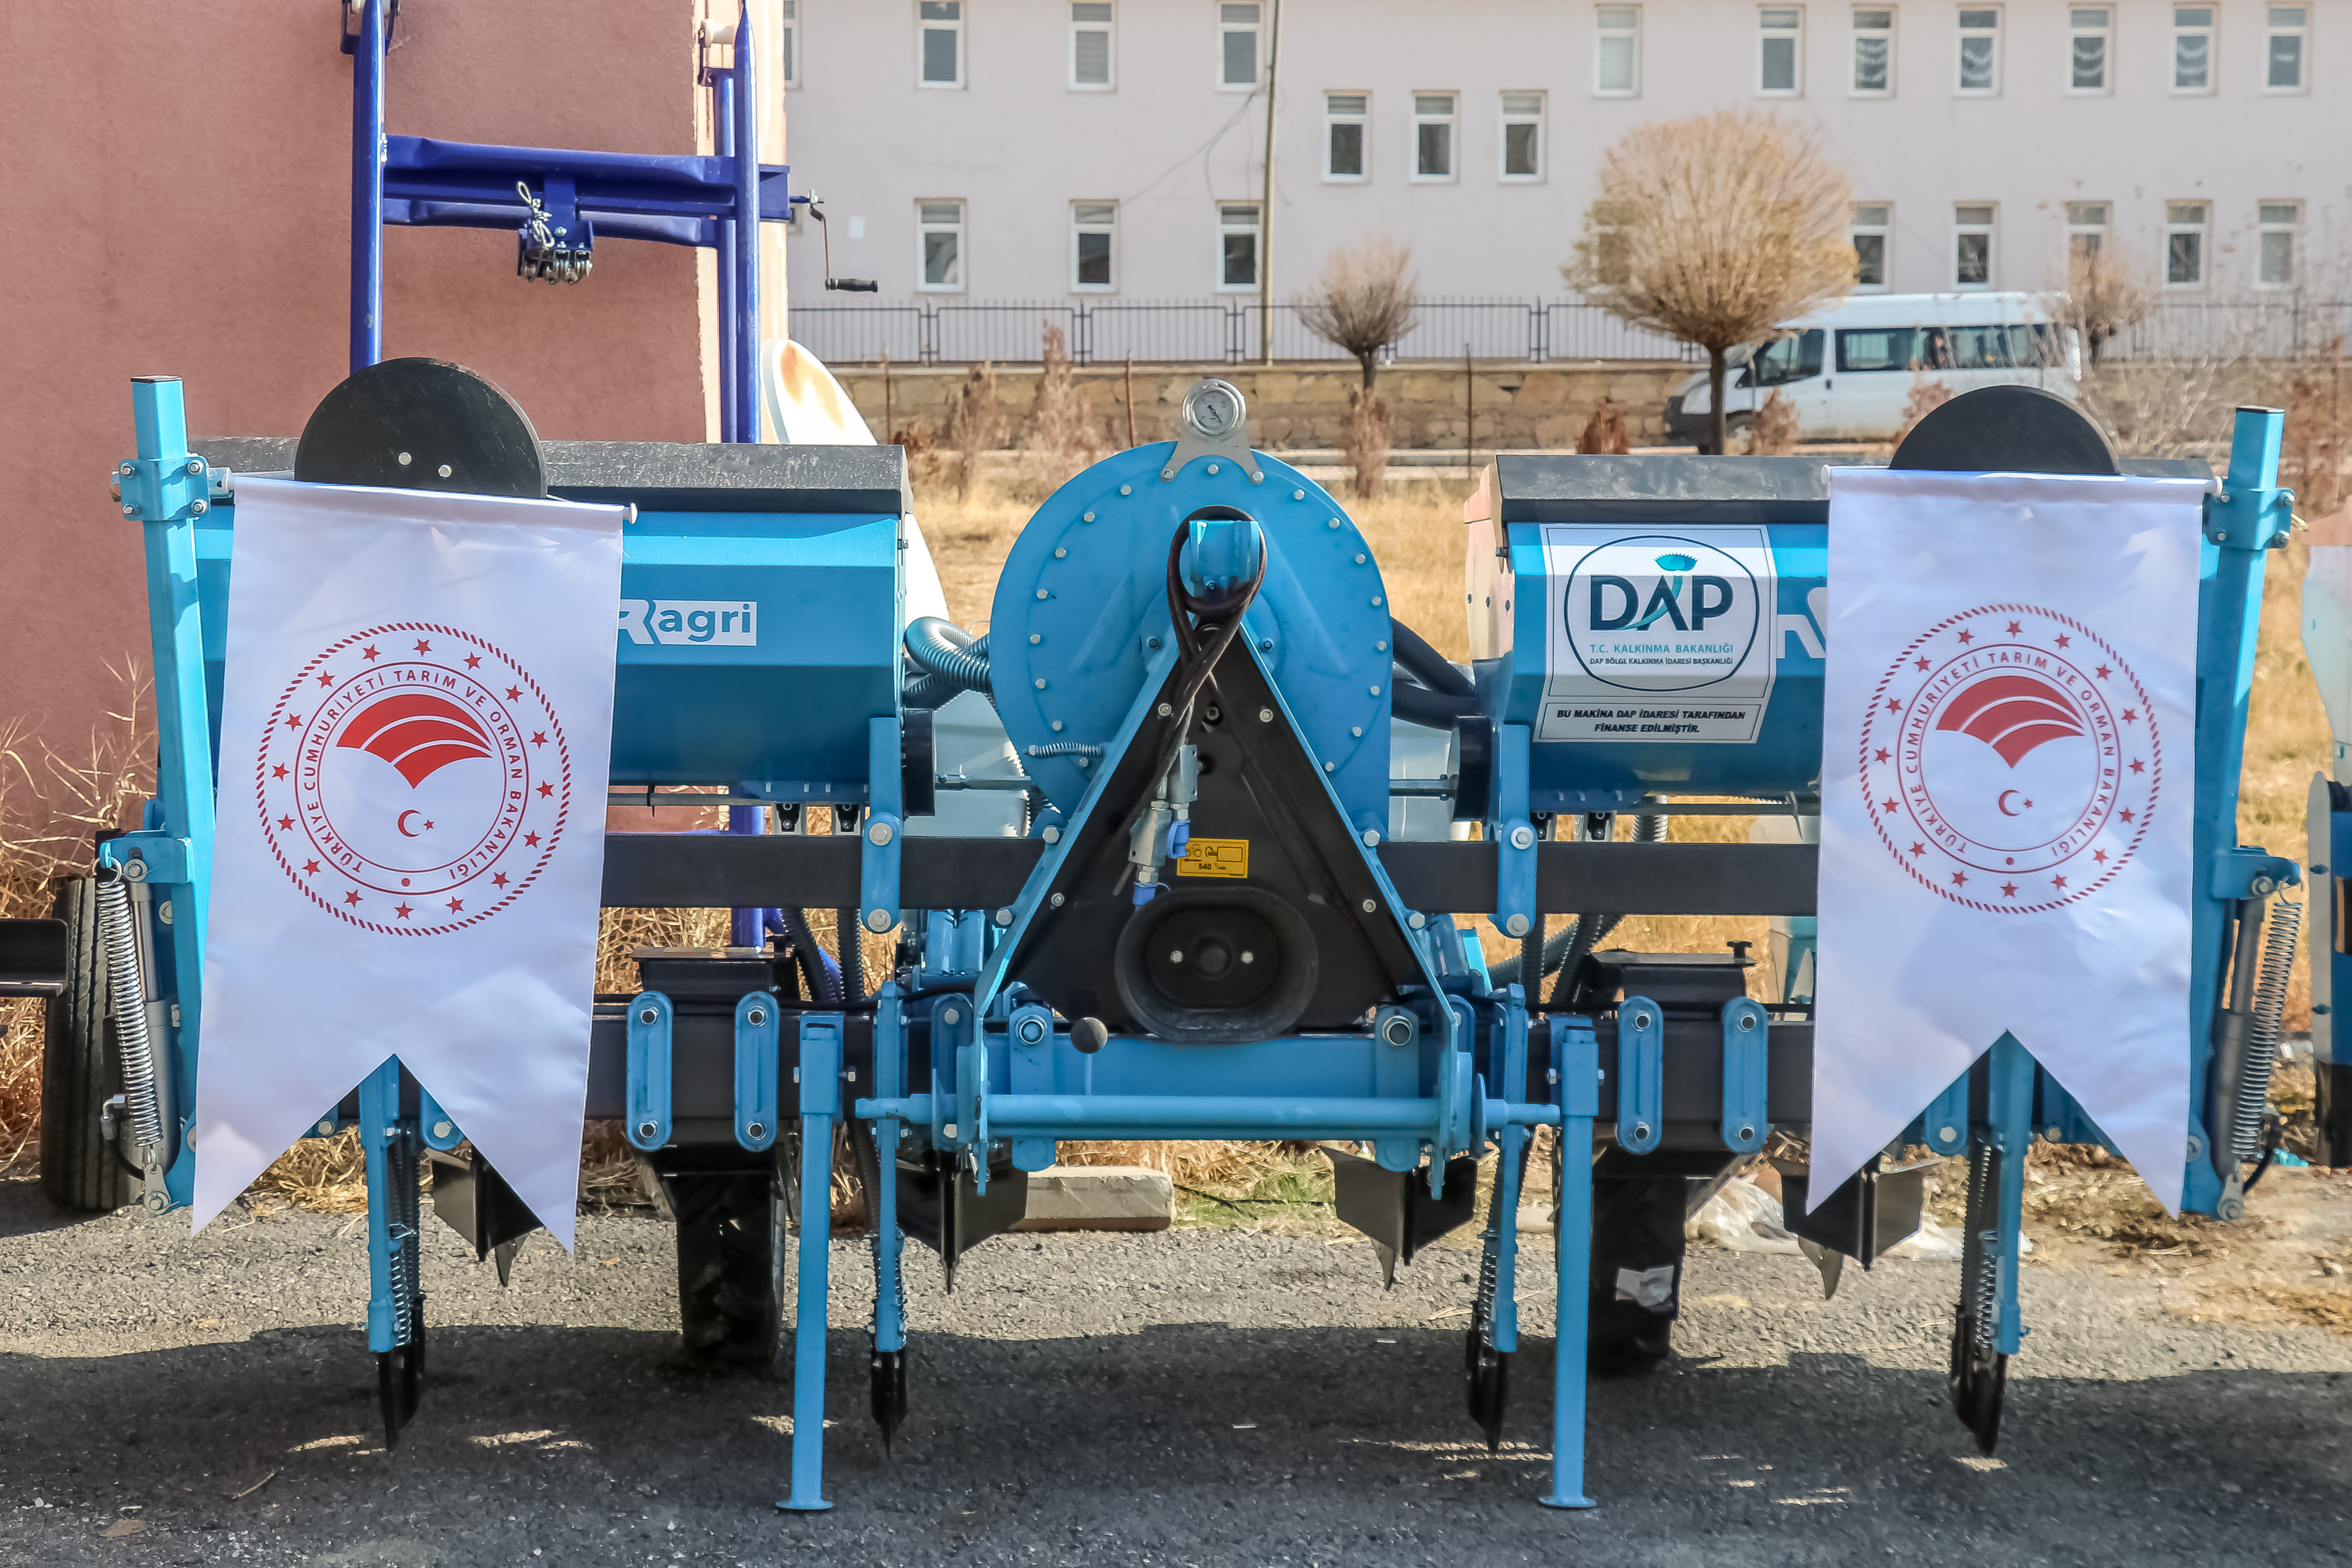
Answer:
1811, 468, 2204, 1210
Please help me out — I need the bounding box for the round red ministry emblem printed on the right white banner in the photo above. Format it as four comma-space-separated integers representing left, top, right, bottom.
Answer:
1858, 604, 2164, 915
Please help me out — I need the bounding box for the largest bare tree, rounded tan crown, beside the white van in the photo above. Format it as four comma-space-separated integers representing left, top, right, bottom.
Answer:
1559, 111, 1856, 451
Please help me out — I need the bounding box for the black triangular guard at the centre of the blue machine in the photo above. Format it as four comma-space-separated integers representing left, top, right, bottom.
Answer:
990, 637, 1437, 1042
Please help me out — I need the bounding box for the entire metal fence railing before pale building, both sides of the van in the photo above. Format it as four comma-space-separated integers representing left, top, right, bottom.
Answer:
793, 294, 2352, 365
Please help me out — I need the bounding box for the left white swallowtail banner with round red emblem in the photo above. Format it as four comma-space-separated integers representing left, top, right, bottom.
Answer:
193, 477, 623, 1248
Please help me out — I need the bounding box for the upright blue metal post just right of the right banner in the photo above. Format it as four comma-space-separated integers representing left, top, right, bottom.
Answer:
2180, 409, 2291, 1213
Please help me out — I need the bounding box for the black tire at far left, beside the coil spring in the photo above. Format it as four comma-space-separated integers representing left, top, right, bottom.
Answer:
40, 877, 141, 1213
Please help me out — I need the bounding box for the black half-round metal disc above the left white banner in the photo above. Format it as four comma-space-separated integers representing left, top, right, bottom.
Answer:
294, 360, 548, 496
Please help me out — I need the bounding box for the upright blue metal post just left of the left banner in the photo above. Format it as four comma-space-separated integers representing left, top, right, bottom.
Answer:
122, 376, 214, 1203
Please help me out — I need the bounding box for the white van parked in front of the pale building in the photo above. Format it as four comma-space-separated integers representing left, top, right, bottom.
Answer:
1665, 294, 2082, 449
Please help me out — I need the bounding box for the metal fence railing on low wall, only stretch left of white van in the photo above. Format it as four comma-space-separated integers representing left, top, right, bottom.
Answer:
793, 294, 1700, 365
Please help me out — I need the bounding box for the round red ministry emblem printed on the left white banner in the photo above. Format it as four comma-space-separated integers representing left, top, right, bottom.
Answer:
254, 621, 572, 936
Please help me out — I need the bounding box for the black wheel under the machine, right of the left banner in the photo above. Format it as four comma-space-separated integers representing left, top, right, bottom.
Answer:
663, 1171, 786, 1368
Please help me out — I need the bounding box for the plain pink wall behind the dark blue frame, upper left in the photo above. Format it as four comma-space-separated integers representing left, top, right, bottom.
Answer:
0, 0, 708, 808
